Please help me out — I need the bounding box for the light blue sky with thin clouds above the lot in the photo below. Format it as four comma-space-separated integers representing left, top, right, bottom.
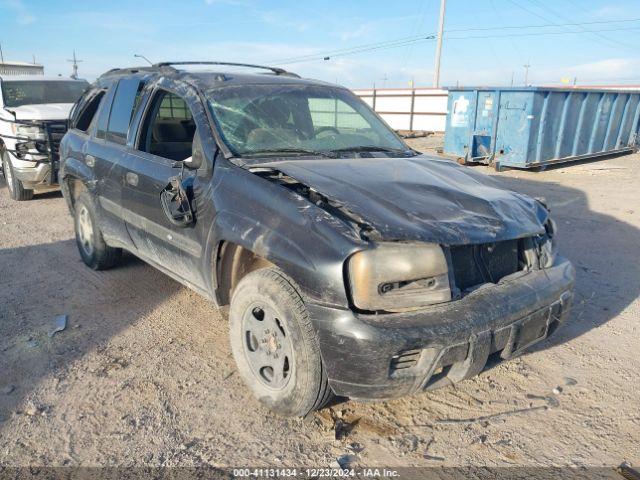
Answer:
0, 0, 640, 88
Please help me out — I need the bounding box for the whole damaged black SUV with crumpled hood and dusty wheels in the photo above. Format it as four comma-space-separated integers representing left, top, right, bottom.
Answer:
60, 62, 574, 415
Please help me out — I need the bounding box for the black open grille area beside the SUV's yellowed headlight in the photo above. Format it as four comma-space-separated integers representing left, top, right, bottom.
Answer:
450, 240, 518, 290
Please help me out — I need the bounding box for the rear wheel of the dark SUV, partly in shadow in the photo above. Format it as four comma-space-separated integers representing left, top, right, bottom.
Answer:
74, 192, 122, 270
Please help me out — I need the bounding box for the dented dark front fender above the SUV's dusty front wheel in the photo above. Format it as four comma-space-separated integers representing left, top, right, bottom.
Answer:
208, 158, 366, 308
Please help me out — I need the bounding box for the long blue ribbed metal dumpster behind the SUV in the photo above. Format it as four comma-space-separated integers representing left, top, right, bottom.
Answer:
444, 87, 640, 169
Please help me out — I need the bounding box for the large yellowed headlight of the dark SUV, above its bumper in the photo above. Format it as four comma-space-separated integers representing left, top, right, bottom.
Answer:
348, 243, 451, 312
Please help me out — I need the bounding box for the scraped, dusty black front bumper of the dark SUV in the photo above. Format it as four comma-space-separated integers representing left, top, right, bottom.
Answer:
307, 258, 575, 399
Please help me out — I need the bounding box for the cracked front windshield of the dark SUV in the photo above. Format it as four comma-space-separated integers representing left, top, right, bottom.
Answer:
207, 85, 408, 156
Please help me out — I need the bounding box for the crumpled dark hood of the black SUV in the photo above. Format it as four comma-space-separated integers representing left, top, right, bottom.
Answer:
247, 155, 548, 245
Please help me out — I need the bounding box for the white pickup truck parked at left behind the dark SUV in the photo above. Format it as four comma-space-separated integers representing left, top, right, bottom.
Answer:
0, 75, 88, 200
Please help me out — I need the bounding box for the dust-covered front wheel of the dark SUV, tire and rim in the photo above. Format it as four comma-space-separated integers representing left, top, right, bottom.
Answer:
229, 268, 333, 416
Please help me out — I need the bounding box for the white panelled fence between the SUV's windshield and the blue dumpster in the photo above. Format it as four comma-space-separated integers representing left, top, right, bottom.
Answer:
353, 88, 448, 132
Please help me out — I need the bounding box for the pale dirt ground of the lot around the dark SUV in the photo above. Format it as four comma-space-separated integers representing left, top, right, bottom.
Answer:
0, 138, 640, 467
